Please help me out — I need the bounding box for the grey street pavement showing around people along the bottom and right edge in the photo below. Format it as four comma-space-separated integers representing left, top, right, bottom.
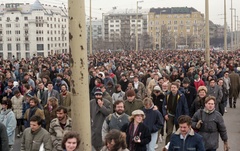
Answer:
13, 100, 240, 151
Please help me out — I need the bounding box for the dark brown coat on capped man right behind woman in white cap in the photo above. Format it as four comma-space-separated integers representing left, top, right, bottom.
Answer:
124, 98, 143, 115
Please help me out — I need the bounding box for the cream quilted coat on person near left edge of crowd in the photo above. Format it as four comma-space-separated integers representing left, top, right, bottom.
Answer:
11, 95, 23, 119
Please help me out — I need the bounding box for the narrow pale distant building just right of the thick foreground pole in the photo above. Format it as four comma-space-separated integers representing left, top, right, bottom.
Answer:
86, 20, 103, 50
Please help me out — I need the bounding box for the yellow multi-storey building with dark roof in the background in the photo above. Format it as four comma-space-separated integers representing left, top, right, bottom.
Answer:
148, 7, 204, 49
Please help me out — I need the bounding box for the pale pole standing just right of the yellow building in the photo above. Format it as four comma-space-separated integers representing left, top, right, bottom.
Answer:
205, 0, 210, 66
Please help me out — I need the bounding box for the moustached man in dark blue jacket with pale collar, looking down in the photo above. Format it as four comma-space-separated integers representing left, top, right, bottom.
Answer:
168, 115, 205, 151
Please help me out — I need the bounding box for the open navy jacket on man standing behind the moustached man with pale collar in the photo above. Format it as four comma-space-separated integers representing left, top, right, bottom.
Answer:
162, 91, 189, 125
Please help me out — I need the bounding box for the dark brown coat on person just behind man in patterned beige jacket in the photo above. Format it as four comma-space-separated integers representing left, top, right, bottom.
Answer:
43, 105, 58, 131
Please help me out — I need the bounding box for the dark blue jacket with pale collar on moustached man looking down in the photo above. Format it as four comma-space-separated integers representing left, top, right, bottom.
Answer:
168, 129, 205, 151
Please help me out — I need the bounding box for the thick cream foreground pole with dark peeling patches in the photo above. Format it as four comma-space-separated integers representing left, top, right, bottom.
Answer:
68, 0, 92, 151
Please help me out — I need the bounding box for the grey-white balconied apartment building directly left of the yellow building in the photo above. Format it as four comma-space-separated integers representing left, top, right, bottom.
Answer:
103, 9, 149, 50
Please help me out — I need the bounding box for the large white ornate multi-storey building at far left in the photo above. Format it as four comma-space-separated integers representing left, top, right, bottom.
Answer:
0, 0, 69, 59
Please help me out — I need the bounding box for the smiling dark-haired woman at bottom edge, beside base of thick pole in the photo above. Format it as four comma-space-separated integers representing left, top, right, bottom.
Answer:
61, 131, 81, 151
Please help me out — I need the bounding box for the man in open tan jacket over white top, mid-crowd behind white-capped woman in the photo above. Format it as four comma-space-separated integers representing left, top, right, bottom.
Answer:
133, 75, 146, 99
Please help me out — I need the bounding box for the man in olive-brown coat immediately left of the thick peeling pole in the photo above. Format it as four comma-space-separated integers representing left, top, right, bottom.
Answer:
60, 84, 72, 117
